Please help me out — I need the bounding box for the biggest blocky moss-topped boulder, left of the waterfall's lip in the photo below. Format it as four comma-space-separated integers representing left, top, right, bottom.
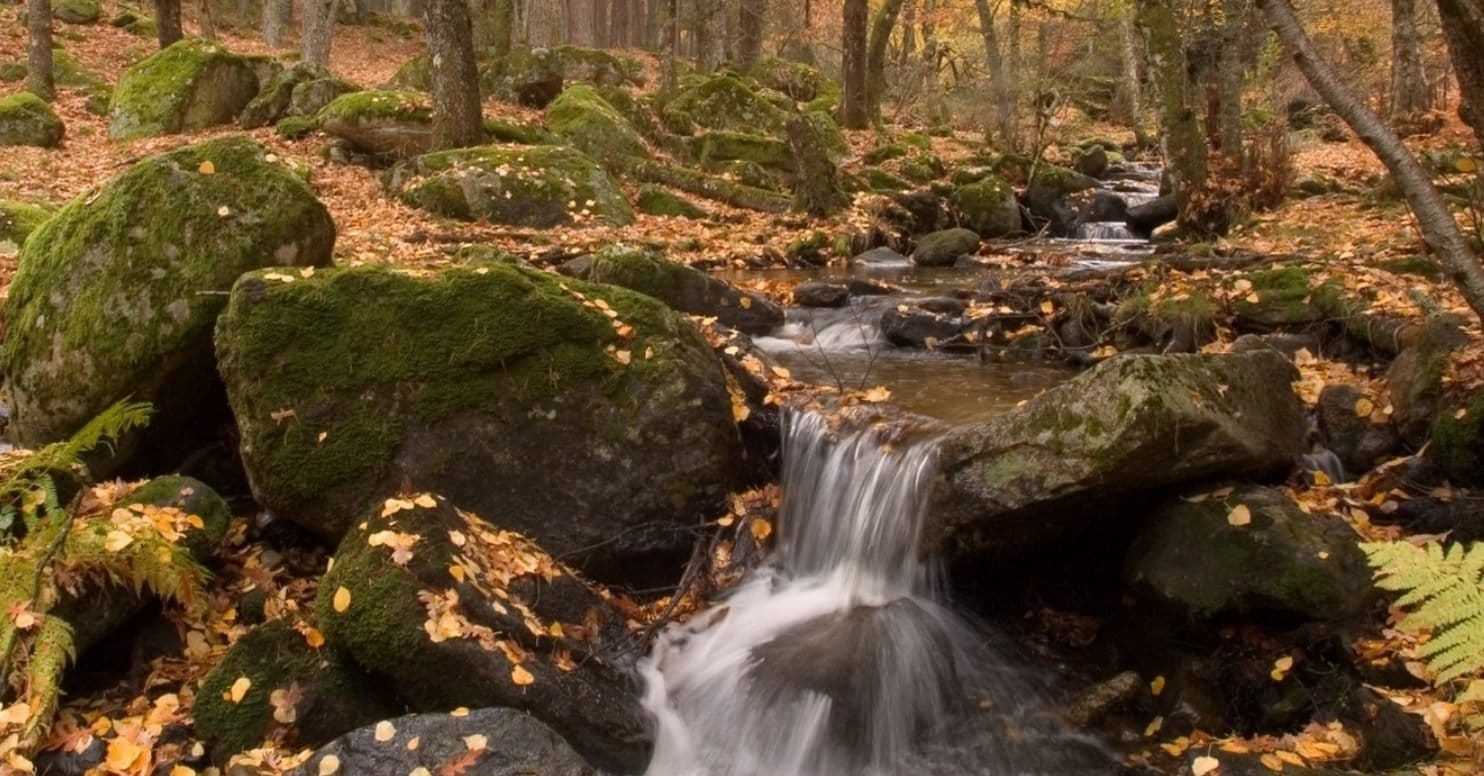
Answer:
217, 263, 741, 568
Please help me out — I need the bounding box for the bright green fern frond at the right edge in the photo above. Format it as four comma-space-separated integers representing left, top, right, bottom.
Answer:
1361, 542, 1484, 684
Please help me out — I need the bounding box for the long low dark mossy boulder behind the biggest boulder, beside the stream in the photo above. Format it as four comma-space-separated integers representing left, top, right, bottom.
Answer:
588, 245, 784, 334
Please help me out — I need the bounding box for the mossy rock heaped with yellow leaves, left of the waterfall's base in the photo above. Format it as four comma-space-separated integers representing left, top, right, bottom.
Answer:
318, 494, 650, 773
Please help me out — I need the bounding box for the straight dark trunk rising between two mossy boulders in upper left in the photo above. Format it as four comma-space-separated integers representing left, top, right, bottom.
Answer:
424, 0, 484, 150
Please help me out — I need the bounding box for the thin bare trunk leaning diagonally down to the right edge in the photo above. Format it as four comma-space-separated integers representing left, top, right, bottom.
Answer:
1257, 0, 1484, 318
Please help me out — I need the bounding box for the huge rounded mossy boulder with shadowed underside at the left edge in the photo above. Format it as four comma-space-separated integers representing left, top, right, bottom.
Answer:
0, 137, 335, 475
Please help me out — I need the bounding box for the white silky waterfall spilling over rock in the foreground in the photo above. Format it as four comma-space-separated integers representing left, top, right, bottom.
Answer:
640, 412, 1112, 776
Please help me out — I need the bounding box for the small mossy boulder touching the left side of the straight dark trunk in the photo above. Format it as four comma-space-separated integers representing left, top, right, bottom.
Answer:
316, 89, 433, 159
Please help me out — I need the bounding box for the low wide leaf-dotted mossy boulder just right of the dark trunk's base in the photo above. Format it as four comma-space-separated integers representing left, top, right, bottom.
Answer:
390, 145, 634, 227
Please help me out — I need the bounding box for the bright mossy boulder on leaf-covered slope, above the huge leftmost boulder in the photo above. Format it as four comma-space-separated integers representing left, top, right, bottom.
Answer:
108, 39, 270, 139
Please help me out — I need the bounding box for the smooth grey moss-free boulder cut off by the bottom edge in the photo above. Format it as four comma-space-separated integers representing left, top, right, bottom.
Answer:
289, 708, 598, 776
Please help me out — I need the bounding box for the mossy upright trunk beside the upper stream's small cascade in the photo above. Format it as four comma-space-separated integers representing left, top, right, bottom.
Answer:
1138, 0, 1206, 231
